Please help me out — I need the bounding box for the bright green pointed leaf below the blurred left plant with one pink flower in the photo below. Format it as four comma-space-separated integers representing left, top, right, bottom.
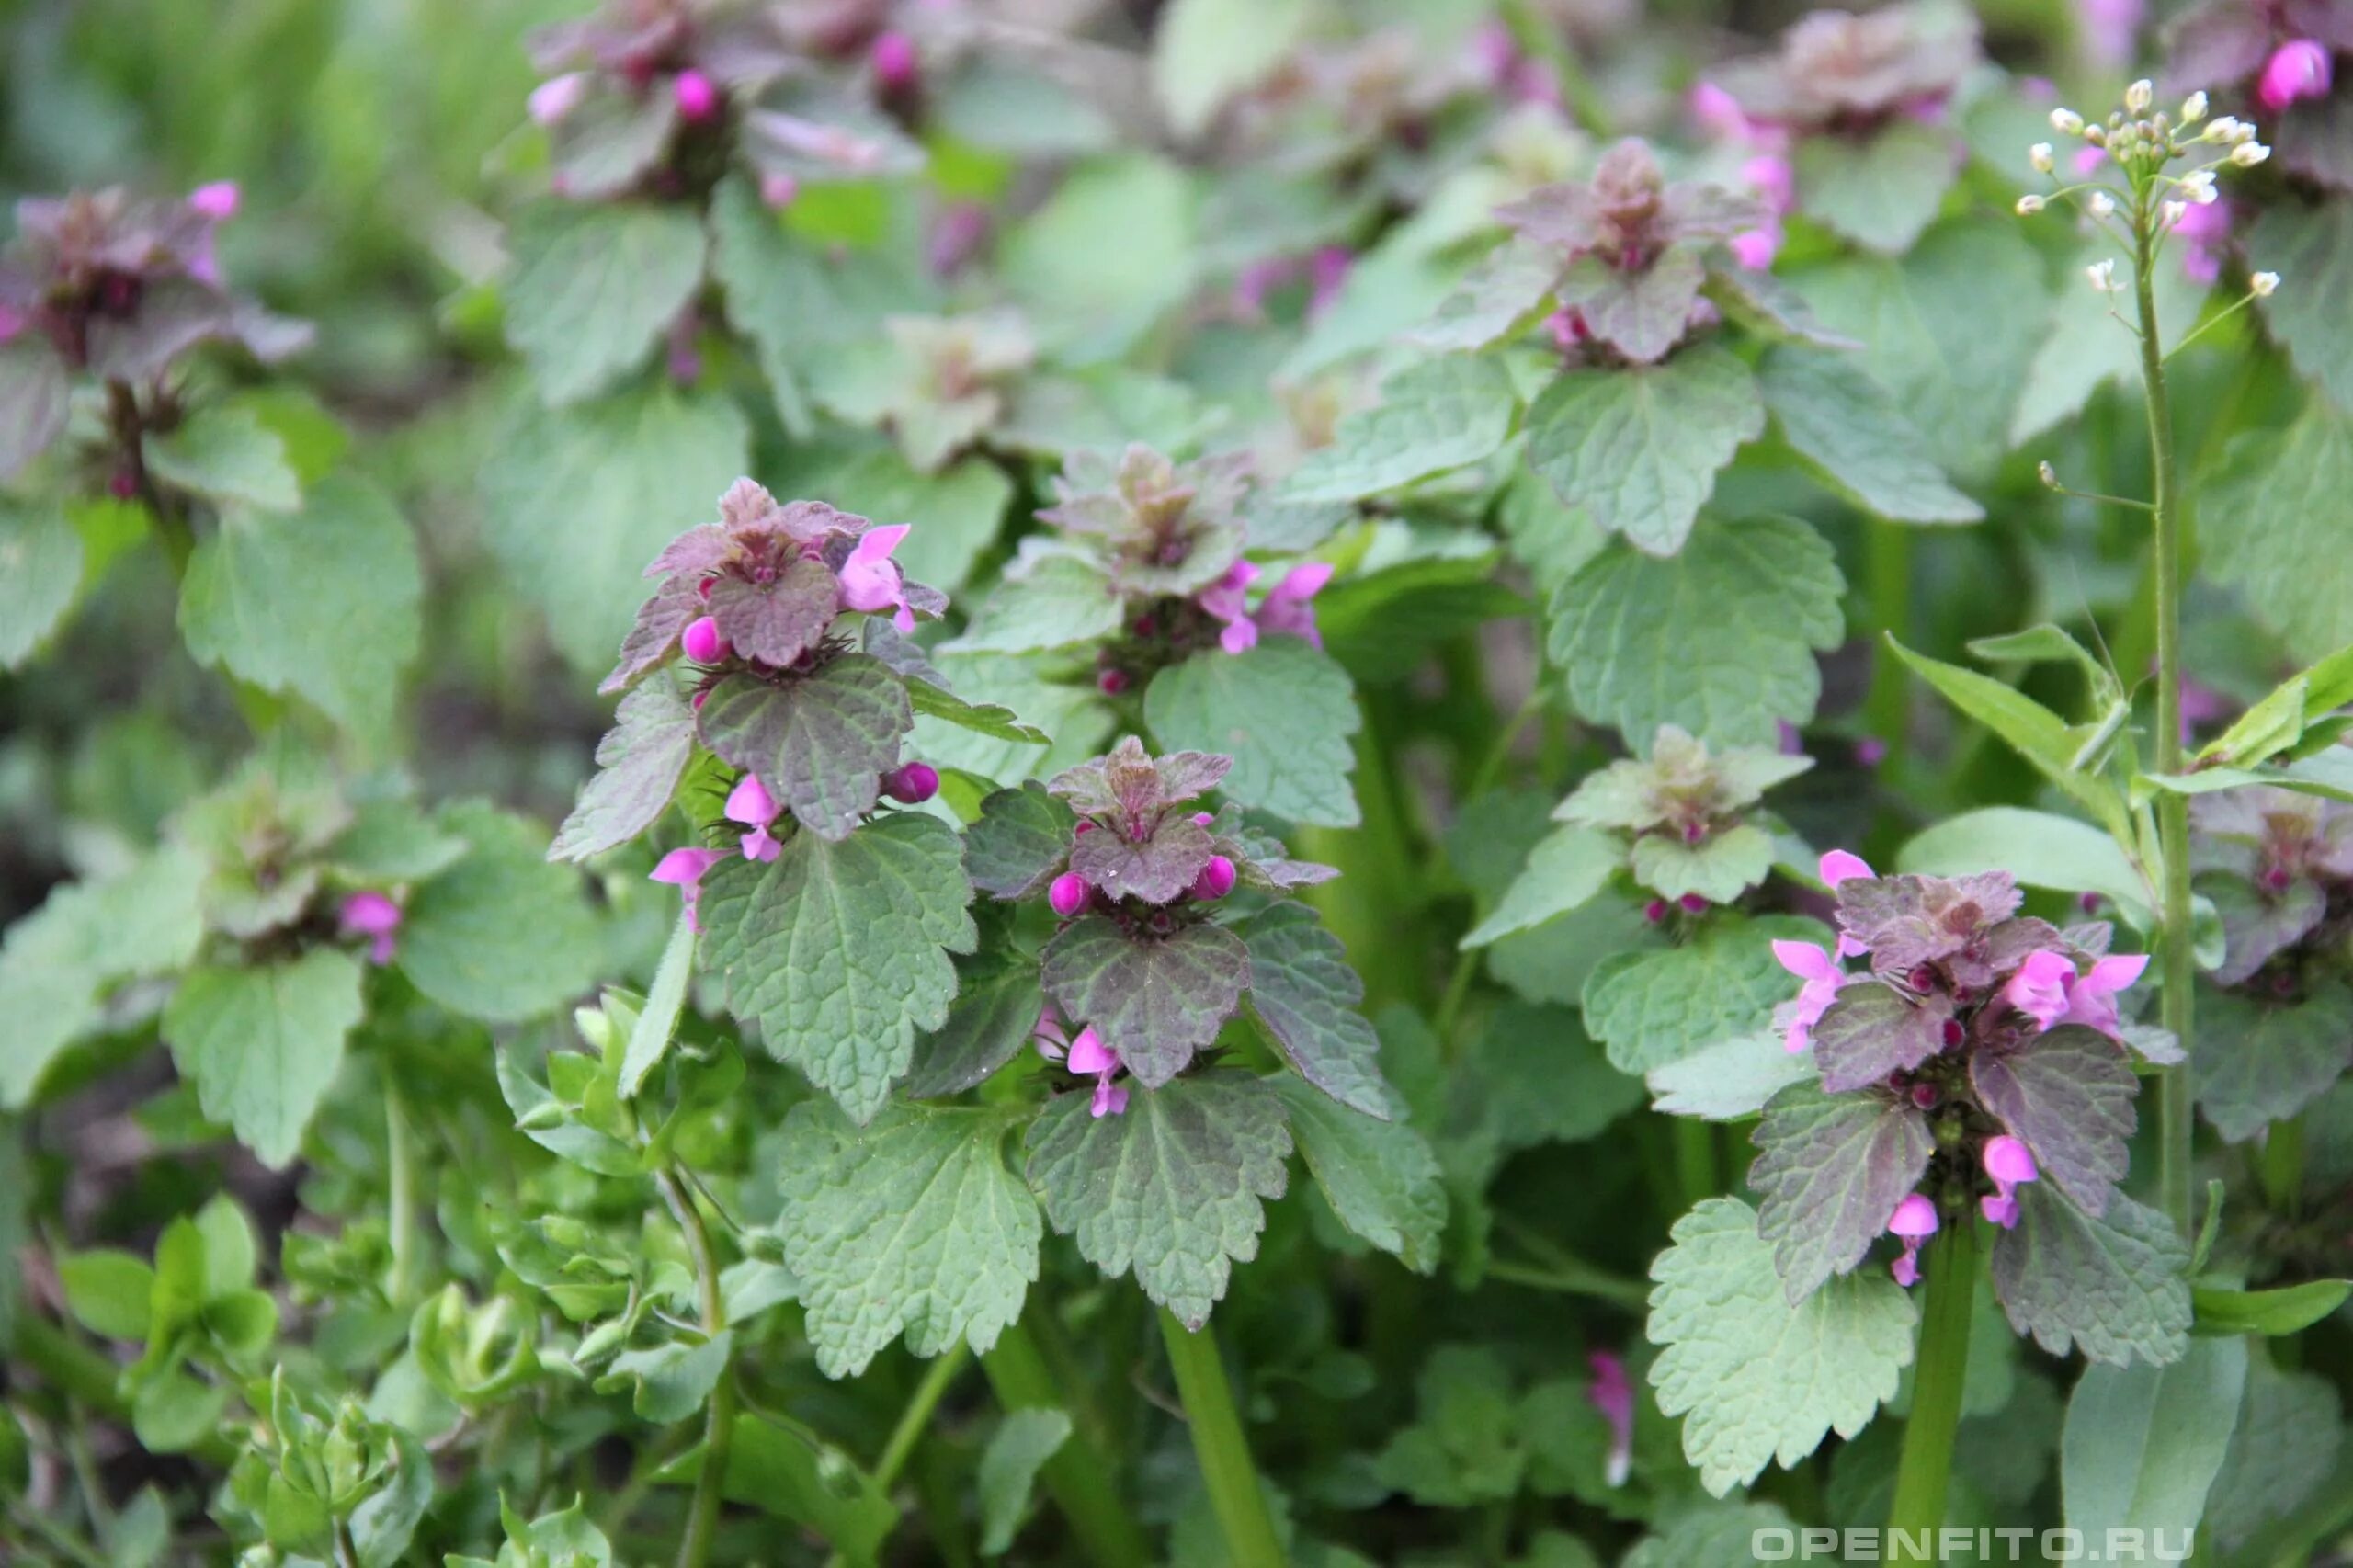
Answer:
163, 947, 362, 1170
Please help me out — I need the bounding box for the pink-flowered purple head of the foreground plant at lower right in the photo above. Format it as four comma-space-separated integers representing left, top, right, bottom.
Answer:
1772, 850, 2163, 1286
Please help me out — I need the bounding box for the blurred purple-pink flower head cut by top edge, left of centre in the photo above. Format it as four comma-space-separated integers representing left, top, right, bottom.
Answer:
529, 0, 923, 207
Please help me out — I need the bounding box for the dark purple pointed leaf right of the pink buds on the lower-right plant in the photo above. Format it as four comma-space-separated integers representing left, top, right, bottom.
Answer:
1970, 1024, 2139, 1217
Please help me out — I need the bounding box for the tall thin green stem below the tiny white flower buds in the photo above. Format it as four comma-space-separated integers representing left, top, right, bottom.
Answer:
2131, 190, 2198, 1236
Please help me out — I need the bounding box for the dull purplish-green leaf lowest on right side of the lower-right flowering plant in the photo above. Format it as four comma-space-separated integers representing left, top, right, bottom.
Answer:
1993, 1182, 2190, 1366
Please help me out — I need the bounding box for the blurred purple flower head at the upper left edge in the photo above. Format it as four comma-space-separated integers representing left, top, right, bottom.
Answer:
0, 181, 311, 478
